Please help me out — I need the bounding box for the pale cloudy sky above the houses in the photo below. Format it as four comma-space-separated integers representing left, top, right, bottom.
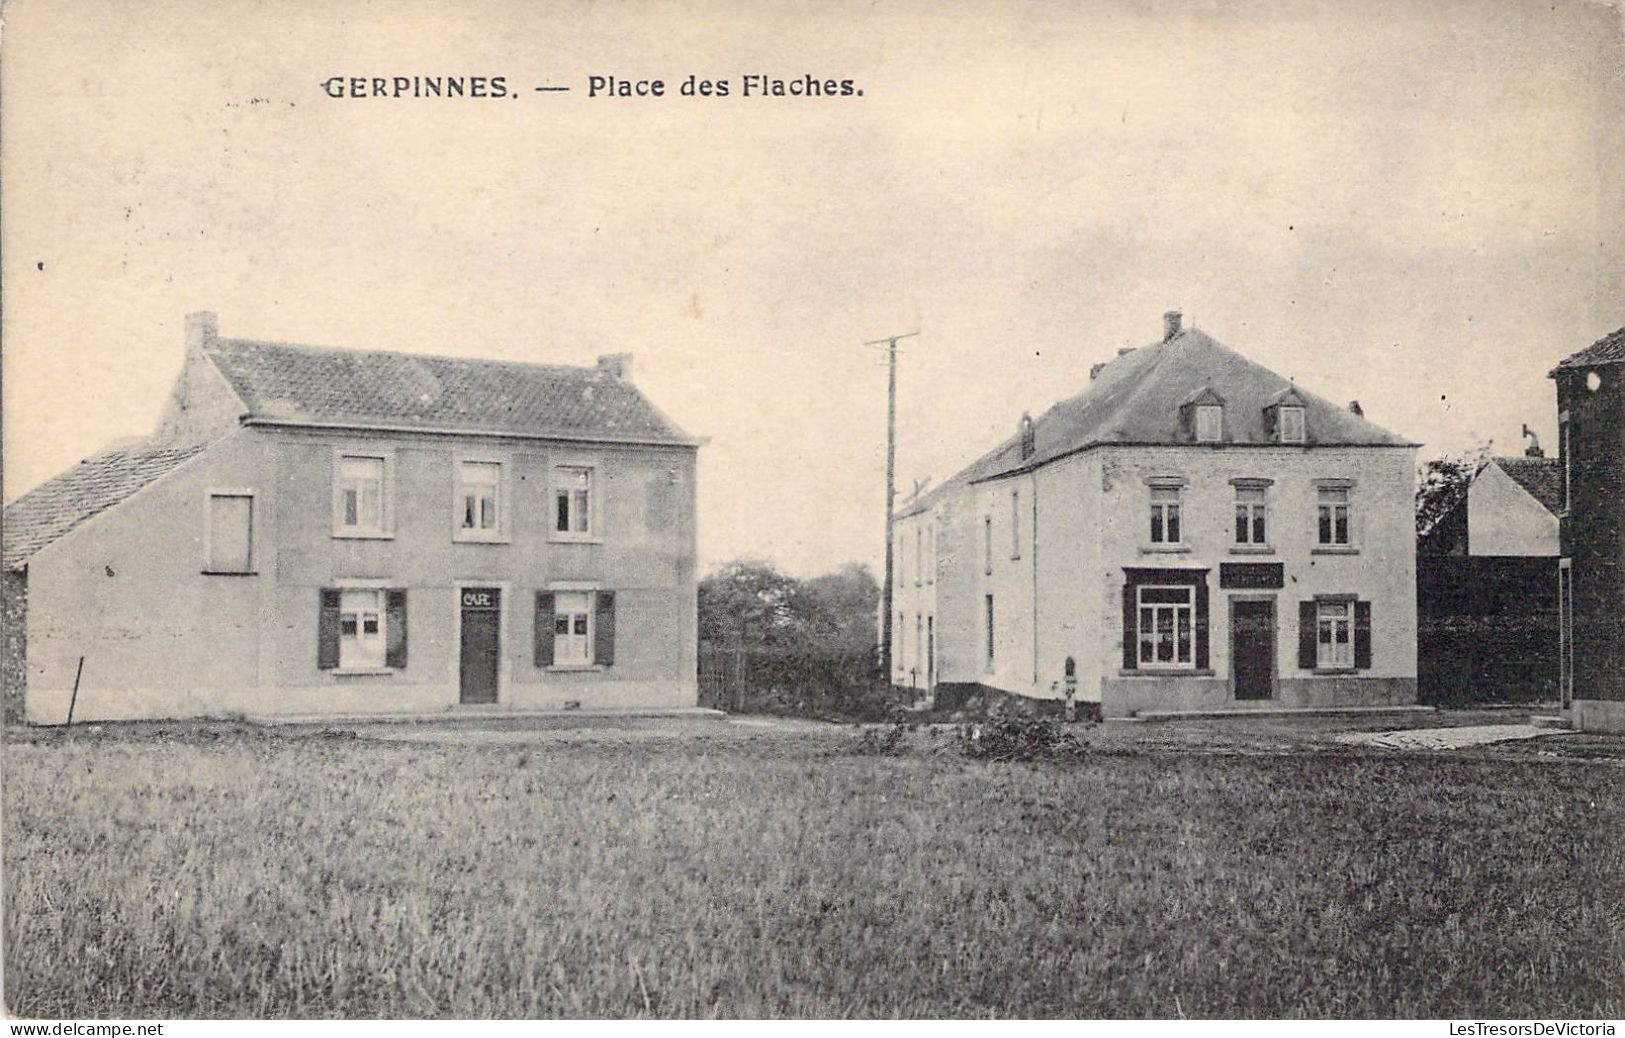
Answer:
0, 0, 1625, 575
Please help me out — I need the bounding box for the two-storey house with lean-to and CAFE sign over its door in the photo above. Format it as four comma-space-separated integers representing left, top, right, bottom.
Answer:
3, 314, 699, 723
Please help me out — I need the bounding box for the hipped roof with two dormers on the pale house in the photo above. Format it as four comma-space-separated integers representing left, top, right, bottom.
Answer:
899, 328, 1415, 515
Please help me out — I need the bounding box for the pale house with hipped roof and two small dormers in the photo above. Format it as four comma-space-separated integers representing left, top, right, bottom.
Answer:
892, 312, 1417, 716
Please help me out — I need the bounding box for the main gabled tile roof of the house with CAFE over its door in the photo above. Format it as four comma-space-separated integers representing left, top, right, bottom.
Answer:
205, 340, 691, 442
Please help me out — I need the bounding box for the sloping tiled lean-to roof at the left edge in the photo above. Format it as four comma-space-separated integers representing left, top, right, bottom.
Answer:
3, 442, 208, 570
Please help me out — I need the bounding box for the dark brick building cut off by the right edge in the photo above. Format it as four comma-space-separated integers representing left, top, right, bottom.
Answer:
1550, 328, 1625, 731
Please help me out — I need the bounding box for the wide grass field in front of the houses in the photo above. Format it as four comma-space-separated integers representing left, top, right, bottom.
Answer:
3, 721, 1625, 1019
